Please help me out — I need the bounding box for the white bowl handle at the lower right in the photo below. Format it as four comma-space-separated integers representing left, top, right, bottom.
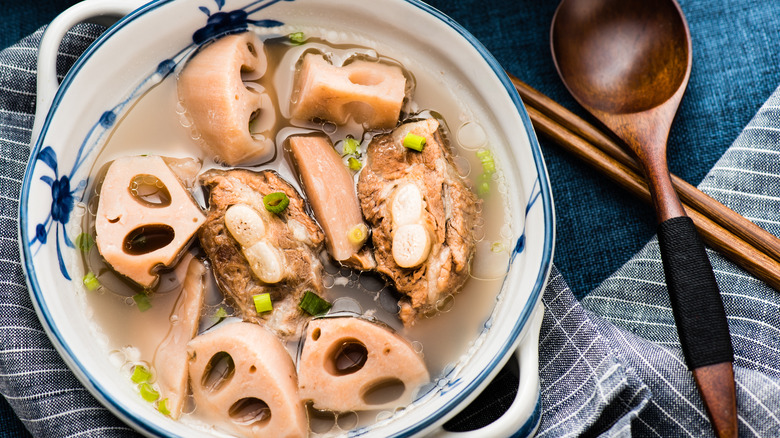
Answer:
432, 304, 544, 438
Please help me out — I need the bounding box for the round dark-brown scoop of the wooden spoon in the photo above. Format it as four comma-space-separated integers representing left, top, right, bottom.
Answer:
551, 0, 691, 114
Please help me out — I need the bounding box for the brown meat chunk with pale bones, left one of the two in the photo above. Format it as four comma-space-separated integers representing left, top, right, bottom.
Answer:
198, 169, 324, 338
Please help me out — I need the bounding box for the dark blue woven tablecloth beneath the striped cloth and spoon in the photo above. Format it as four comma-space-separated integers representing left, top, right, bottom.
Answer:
0, 0, 780, 437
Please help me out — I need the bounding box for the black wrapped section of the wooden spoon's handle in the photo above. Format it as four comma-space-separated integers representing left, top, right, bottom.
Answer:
658, 216, 734, 370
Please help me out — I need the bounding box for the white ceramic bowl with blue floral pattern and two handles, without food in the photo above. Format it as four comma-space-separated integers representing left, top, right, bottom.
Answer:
20, 0, 554, 437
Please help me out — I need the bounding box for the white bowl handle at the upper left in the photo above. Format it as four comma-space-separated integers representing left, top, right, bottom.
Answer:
31, 0, 149, 145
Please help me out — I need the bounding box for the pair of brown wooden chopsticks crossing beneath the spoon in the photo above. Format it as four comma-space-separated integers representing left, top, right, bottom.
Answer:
510, 75, 780, 289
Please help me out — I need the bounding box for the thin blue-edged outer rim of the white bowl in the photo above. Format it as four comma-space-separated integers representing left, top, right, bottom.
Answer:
19, 0, 555, 436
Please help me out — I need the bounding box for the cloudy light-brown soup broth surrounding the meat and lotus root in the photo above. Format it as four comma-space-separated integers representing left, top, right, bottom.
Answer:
73, 24, 512, 436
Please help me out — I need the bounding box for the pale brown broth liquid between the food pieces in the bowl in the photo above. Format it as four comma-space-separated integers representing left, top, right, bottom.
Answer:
73, 30, 512, 435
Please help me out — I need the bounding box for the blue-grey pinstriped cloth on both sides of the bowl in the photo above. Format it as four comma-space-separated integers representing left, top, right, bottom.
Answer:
0, 25, 780, 437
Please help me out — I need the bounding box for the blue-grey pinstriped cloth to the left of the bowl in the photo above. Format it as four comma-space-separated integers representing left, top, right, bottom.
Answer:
0, 25, 136, 437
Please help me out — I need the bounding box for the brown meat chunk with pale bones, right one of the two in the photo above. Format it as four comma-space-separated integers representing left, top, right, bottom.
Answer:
358, 119, 481, 325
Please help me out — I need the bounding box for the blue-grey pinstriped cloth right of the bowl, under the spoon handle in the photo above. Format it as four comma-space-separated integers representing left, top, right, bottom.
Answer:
539, 89, 780, 437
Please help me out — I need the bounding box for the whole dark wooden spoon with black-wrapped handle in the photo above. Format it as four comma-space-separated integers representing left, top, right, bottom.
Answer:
550, 0, 737, 436
